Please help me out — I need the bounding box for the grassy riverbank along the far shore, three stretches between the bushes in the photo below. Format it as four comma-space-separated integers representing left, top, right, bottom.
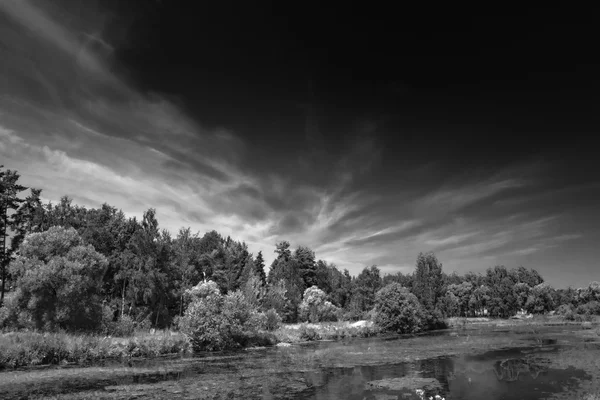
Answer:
0, 316, 600, 370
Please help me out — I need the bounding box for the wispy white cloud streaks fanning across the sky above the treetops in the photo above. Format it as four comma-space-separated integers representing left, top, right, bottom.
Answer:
0, 0, 597, 290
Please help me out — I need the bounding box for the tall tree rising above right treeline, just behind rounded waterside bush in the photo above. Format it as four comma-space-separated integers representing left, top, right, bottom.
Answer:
413, 253, 444, 310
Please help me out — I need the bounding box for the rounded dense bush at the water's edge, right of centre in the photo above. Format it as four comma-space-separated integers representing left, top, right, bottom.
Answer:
375, 282, 427, 333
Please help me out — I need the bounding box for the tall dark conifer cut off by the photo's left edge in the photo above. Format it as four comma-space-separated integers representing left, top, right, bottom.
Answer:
0, 165, 27, 306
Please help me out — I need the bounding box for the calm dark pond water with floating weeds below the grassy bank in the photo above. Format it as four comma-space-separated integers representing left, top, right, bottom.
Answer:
0, 329, 600, 400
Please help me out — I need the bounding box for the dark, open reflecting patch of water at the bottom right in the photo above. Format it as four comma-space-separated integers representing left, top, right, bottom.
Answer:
314, 357, 587, 400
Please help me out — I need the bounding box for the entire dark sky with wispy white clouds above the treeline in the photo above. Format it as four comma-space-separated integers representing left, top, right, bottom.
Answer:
0, 0, 600, 287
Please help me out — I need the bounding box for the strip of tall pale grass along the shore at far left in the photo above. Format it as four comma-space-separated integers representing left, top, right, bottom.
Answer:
0, 331, 189, 369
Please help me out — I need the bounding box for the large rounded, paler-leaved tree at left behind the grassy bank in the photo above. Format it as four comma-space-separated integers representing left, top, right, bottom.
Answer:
10, 227, 107, 330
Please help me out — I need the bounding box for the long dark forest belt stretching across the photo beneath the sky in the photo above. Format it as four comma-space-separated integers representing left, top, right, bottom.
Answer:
0, 166, 600, 340
